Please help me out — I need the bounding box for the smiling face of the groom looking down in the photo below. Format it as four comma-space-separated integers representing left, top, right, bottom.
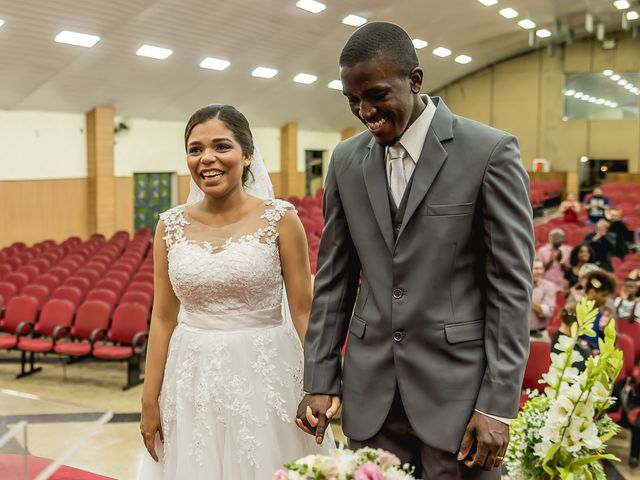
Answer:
340, 55, 424, 145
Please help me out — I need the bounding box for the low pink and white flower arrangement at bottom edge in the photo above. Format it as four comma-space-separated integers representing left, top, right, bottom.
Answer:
274, 447, 414, 480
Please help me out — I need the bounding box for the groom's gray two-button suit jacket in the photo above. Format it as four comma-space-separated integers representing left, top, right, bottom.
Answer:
304, 97, 533, 452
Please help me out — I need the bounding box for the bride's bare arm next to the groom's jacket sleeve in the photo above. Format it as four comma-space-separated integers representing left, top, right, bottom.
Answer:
279, 210, 312, 344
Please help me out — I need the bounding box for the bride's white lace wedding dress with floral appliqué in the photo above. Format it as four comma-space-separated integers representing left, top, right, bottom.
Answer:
141, 200, 334, 480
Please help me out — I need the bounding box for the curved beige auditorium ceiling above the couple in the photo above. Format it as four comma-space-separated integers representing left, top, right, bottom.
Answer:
0, 0, 640, 131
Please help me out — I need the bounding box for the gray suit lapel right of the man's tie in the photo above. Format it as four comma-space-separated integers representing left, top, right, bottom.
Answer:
396, 97, 453, 242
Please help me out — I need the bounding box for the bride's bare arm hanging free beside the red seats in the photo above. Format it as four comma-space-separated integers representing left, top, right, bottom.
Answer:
140, 221, 180, 461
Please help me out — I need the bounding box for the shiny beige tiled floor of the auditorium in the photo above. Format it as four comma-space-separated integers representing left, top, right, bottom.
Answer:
0, 352, 640, 480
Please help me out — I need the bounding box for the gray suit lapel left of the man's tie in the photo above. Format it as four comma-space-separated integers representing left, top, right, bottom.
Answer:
362, 139, 393, 253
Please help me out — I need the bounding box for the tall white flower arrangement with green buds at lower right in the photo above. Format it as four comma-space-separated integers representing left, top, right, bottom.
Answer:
505, 298, 623, 480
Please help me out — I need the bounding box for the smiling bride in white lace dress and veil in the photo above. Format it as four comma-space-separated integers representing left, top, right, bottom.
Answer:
140, 105, 337, 480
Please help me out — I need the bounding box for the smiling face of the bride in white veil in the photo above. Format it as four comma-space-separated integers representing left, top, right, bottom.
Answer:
187, 118, 250, 197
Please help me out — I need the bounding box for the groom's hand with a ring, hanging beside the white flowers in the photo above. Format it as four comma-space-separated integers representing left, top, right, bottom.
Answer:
458, 411, 509, 471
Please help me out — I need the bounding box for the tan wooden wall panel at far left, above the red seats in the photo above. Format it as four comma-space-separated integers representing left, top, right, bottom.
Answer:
0, 178, 93, 247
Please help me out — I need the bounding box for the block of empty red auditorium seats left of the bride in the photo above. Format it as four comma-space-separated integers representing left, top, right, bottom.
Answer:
0, 229, 153, 388
